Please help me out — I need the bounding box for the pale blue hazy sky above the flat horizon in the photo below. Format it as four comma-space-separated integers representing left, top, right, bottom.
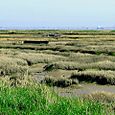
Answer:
0, 0, 115, 28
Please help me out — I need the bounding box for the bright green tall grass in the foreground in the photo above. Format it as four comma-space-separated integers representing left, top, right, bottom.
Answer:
0, 84, 106, 115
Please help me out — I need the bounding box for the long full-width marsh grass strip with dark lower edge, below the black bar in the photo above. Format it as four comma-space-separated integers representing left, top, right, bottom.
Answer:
0, 40, 115, 56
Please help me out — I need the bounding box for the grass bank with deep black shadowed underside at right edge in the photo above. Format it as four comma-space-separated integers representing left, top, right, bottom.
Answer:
71, 70, 115, 85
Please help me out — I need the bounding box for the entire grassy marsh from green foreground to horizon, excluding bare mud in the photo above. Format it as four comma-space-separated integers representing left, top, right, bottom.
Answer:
0, 30, 115, 115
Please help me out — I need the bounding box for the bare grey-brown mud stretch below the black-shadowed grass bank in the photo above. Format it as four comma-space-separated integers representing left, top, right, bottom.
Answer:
54, 84, 115, 96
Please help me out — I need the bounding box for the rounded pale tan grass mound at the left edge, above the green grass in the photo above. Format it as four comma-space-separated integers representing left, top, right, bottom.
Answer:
0, 56, 28, 76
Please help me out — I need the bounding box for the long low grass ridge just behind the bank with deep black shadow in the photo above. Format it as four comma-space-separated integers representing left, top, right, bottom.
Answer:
45, 60, 115, 71
